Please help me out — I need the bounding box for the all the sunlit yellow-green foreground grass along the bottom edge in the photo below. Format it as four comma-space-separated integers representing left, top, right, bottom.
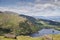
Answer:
0, 34, 60, 40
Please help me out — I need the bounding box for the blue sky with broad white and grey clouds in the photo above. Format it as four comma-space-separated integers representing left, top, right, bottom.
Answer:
0, 0, 60, 17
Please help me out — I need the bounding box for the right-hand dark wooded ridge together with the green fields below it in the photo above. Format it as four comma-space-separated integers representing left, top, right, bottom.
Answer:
37, 19, 60, 30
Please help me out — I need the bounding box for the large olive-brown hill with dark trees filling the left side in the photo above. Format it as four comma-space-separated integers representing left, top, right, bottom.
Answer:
0, 11, 38, 35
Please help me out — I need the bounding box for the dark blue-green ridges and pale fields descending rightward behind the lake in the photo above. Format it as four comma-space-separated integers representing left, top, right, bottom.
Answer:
20, 15, 60, 30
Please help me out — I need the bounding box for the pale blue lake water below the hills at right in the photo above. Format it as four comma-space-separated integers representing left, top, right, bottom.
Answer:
30, 29, 60, 37
